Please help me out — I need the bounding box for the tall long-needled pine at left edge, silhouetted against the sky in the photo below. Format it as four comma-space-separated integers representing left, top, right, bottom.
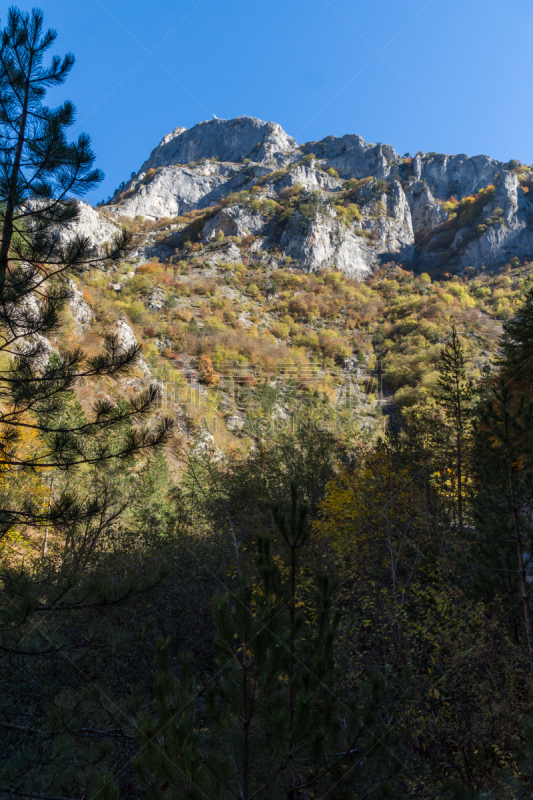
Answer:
0, 8, 170, 538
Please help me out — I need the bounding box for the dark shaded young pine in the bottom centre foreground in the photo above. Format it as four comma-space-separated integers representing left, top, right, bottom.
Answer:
131, 491, 401, 800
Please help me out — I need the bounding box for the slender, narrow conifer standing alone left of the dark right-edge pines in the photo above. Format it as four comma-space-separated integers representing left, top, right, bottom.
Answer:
437, 326, 474, 530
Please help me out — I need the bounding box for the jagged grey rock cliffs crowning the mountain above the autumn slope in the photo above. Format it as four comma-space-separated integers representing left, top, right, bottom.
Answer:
103, 117, 533, 277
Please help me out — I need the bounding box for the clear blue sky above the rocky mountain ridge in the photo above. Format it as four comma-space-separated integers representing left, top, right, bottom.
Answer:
10, 0, 533, 202
